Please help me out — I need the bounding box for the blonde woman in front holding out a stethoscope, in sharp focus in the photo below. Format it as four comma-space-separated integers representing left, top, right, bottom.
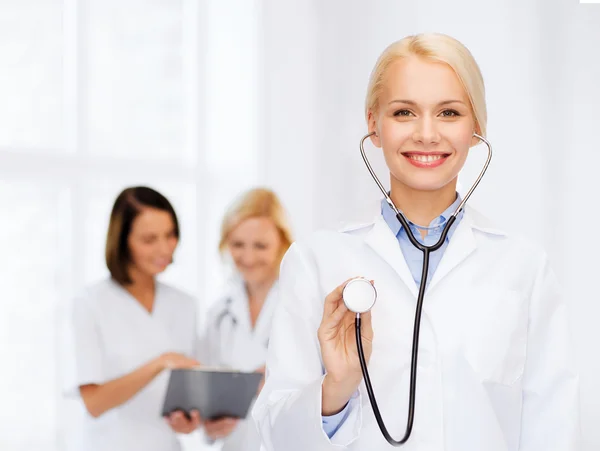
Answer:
253, 34, 579, 451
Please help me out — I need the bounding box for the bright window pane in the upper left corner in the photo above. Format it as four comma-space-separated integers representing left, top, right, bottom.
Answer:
0, 0, 63, 150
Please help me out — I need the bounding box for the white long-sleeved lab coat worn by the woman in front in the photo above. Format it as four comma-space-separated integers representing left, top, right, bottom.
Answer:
253, 208, 579, 451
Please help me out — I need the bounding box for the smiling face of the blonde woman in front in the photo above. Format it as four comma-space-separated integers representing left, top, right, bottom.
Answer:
369, 57, 477, 191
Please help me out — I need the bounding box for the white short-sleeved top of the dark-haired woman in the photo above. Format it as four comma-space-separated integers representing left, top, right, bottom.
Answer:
68, 279, 197, 451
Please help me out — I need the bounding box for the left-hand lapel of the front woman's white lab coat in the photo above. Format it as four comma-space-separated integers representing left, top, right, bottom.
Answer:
365, 215, 417, 298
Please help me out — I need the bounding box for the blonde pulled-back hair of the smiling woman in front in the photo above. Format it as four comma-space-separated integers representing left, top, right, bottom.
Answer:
365, 33, 487, 137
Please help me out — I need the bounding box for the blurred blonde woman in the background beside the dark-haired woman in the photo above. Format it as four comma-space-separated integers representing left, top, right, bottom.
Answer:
200, 189, 292, 451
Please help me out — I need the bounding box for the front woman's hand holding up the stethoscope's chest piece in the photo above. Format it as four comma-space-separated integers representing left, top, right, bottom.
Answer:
318, 278, 373, 416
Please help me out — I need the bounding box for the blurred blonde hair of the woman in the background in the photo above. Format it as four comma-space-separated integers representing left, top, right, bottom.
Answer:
219, 188, 294, 262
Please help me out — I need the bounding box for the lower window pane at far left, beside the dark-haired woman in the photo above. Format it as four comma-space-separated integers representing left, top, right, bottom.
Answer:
0, 180, 69, 451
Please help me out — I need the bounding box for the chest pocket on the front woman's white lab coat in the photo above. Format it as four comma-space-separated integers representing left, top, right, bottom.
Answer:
464, 286, 528, 385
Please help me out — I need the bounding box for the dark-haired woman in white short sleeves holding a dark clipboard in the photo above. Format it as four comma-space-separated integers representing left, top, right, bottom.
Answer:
64, 187, 200, 451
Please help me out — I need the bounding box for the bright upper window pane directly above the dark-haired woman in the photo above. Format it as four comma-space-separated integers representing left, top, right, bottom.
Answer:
82, 0, 184, 159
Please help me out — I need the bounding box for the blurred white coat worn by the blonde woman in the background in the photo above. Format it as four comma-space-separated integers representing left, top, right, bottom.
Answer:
199, 275, 279, 451
